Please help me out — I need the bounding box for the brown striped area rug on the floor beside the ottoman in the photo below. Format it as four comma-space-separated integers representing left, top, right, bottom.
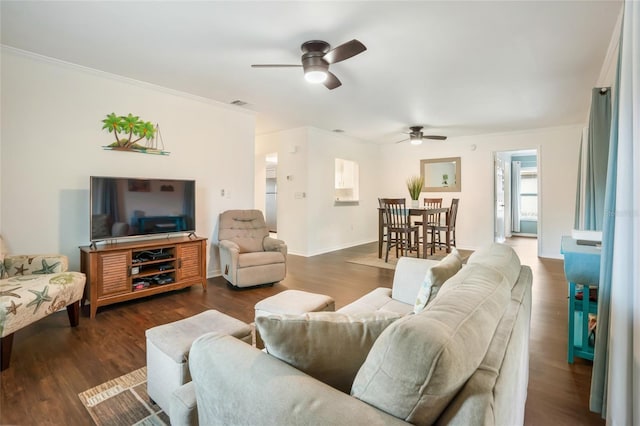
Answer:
78, 367, 170, 426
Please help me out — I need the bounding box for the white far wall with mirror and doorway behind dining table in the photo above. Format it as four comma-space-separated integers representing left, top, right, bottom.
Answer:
377, 125, 582, 258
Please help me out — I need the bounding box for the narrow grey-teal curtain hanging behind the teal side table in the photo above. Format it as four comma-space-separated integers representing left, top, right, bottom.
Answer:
584, 88, 611, 231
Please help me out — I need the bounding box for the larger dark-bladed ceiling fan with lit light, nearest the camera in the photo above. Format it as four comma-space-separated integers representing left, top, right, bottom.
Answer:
251, 39, 367, 90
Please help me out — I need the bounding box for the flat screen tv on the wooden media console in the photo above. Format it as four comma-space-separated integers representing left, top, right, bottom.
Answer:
90, 176, 196, 242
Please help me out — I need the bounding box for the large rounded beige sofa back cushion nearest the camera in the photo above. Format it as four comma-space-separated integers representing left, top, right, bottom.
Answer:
351, 264, 511, 424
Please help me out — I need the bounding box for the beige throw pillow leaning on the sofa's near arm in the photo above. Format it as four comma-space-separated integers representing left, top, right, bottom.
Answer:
256, 311, 402, 393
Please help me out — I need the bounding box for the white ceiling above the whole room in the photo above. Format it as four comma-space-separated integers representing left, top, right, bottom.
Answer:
1, 0, 621, 143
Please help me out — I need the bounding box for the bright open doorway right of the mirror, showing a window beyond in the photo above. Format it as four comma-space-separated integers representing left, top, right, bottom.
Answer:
494, 149, 541, 251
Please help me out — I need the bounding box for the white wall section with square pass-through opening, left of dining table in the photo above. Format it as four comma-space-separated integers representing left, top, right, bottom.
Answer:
256, 128, 378, 256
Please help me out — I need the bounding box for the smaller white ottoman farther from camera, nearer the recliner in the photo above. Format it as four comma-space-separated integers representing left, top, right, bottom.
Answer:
255, 290, 336, 349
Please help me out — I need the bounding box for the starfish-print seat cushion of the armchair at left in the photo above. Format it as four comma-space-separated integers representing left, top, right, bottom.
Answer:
0, 272, 86, 337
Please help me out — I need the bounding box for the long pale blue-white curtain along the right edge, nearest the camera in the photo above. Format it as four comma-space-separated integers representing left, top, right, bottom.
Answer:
589, 1, 640, 426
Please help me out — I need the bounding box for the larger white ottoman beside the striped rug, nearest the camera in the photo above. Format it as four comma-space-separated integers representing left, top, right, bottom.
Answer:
146, 310, 251, 416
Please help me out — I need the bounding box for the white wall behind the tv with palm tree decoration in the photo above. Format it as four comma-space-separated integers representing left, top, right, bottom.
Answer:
0, 48, 255, 276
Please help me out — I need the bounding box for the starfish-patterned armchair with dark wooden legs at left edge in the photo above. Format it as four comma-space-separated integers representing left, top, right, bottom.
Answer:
0, 239, 86, 370
